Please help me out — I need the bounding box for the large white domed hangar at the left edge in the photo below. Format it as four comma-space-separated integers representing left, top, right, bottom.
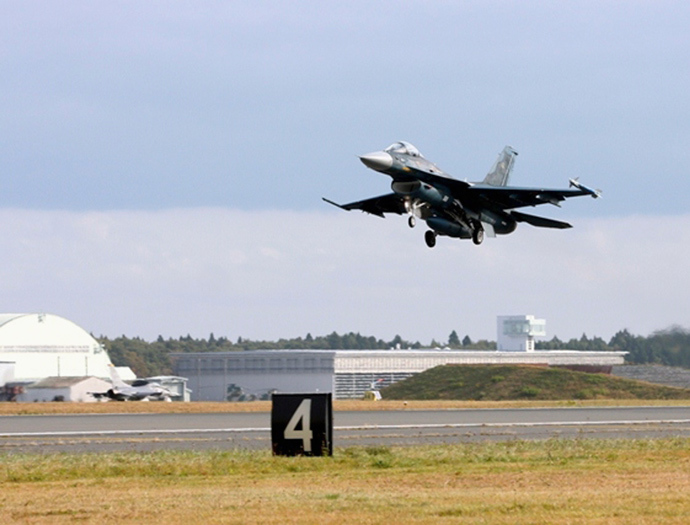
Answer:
0, 313, 111, 382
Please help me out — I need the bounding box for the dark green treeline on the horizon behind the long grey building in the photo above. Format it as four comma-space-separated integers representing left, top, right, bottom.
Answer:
98, 326, 690, 377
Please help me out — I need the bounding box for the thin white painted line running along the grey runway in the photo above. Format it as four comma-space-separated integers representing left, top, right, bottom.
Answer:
0, 419, 690, 438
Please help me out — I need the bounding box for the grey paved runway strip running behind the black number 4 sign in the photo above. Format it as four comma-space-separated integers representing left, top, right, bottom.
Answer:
0, 407, 690, 453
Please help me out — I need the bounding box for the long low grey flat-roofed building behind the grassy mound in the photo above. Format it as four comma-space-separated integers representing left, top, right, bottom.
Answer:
171, 350, 626, 401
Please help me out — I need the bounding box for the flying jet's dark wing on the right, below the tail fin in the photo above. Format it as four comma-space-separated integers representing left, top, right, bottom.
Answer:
464, 185, 599, 210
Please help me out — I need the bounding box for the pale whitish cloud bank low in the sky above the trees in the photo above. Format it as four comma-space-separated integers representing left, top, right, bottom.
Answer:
0, 208, 690, 343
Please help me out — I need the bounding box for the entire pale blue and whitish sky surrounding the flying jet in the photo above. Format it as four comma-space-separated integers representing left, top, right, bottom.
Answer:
0, 0, 690, 344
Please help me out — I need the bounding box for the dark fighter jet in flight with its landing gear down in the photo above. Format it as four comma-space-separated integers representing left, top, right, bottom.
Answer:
323, 141, 601, 248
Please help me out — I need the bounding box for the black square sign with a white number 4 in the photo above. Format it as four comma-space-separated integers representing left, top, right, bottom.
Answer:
271, 393, 333, 456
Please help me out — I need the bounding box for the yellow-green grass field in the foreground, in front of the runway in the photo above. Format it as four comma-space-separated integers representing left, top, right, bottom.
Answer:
0, 439, 690, 524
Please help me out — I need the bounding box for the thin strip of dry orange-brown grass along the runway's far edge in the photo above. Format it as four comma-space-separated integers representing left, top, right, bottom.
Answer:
0, 399, 690, 416
